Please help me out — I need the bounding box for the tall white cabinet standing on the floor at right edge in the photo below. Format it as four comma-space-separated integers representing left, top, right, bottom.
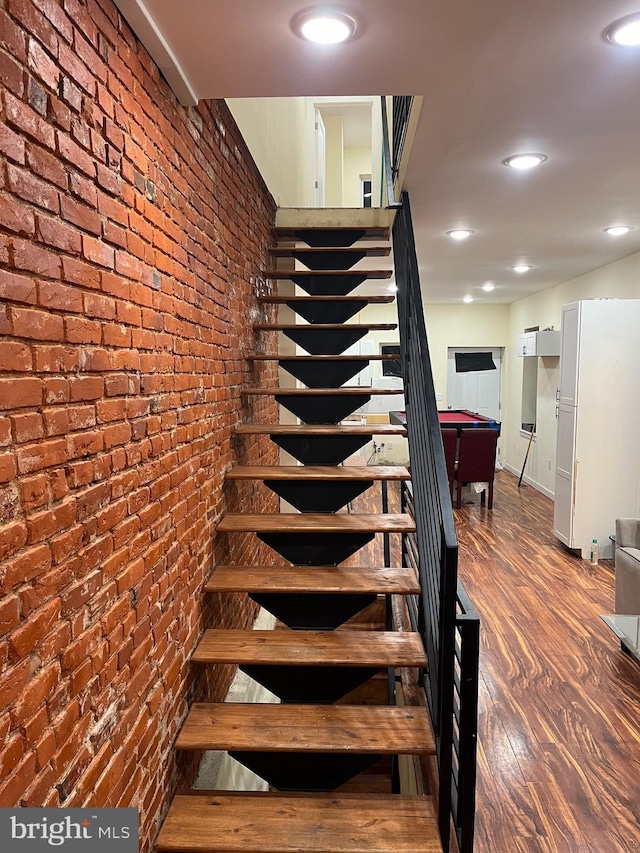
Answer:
553, 299, 640, 557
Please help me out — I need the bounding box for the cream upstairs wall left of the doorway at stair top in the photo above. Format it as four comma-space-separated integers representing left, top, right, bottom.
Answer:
227, 98, 313, 207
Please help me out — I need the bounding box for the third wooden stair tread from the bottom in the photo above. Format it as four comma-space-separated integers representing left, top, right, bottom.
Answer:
191, 628, 427, 669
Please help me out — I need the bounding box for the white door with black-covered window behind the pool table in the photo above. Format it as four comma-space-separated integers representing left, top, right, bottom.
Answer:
447, 347, 502, 421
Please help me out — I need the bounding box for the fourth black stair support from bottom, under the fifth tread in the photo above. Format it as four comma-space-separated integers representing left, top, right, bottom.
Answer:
256, 531, 375, 566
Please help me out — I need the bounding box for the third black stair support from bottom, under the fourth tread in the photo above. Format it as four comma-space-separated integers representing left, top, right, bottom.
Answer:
249, 592, 378, 631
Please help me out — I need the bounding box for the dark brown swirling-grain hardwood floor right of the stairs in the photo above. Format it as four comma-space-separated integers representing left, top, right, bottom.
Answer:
455, 472, 640, 853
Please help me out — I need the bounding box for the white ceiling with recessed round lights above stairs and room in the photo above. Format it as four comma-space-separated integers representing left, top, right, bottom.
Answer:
116, 0, 640, 304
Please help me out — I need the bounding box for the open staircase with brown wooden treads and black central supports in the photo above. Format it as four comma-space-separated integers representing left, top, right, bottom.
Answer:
156, 218, 442, 853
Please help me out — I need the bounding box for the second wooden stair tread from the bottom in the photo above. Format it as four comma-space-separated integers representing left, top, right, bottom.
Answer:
176, 702, 435, 755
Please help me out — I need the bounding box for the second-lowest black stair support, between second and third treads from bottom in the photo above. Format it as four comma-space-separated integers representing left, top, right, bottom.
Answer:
240, 664, 383, 705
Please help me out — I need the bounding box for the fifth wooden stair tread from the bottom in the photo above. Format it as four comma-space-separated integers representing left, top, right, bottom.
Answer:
218, 512, 416, 533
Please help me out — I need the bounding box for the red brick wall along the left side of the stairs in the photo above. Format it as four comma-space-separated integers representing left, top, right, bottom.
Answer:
0, 0, 275, 851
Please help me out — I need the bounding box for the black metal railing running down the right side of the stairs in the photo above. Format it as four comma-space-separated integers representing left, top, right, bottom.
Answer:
393, 192, 479, 853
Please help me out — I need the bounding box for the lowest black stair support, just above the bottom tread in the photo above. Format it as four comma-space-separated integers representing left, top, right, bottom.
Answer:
229, 744, 381, 793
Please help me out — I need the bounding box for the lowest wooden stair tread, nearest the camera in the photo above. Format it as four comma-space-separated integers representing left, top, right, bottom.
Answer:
155, 791, 442, 853
